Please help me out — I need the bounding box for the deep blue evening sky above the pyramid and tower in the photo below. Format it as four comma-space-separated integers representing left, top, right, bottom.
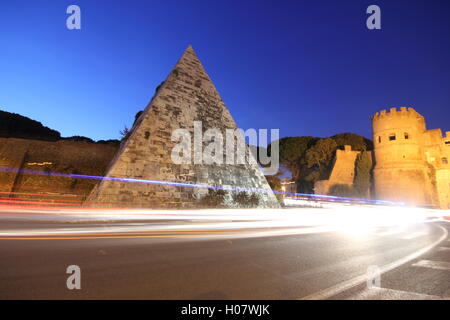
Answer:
0, 0, 450, 139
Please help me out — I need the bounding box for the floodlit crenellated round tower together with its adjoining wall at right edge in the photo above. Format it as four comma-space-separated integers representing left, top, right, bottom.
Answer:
372, 107, 450, 209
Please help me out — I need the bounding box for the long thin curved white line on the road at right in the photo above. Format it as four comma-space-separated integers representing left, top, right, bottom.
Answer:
299, 226, 448, 300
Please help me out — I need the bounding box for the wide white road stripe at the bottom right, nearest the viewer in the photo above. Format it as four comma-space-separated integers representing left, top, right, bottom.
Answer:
347, 288, 450, 300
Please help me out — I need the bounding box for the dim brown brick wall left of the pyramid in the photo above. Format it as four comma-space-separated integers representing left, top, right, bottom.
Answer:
0, 138, 117, 198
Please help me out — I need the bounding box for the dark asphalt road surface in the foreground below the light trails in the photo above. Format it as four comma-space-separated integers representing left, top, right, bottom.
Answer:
0, 209, 450, 299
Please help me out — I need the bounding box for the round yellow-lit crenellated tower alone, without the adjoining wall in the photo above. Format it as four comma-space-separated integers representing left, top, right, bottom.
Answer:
372, 107, 435, 205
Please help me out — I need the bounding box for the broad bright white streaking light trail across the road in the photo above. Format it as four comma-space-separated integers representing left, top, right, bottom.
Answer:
0, 204, 442, 240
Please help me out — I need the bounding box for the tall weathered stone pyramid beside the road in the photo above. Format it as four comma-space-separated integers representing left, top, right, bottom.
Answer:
87, 46, 278, 208
